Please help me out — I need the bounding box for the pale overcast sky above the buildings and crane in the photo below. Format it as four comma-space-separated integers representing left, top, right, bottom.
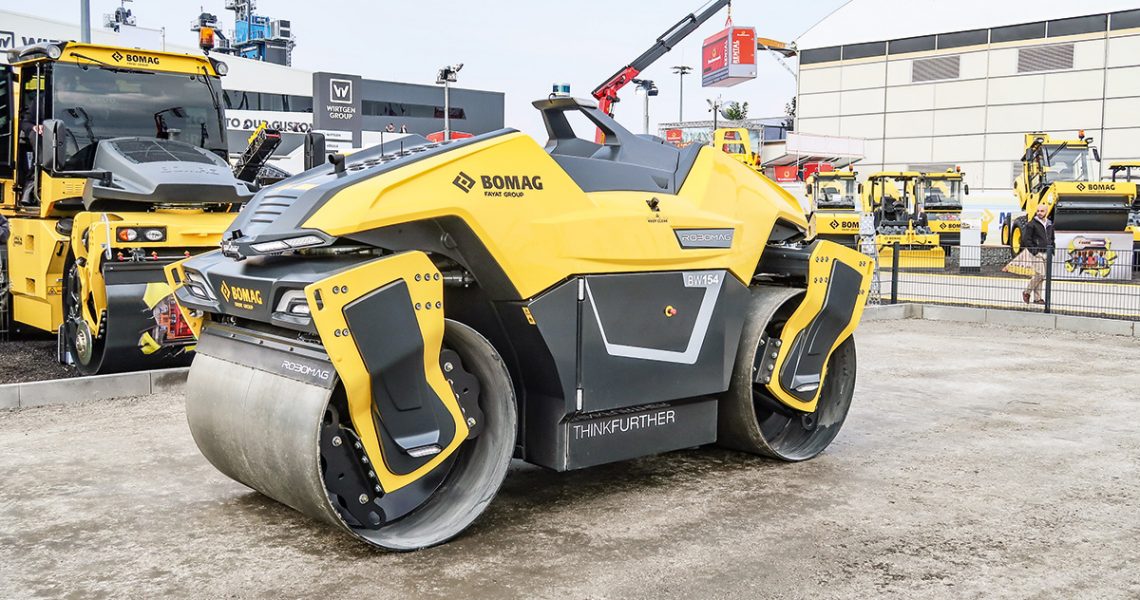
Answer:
14, 0, 845, 139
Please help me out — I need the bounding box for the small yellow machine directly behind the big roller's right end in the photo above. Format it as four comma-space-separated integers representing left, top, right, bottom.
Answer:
804, 170, 862, 248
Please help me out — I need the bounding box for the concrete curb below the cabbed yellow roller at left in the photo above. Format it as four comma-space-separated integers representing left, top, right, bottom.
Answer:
0, 367, 189, 410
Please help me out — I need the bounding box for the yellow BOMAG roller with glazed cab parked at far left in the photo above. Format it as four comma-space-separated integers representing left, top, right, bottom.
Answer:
0, 42, 253, 374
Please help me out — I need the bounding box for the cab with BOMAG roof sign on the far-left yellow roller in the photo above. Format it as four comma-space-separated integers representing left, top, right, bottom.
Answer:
0, 42, 228, 217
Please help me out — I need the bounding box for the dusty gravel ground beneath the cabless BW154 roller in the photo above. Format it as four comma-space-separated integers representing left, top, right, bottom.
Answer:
0, 321, 1140, 600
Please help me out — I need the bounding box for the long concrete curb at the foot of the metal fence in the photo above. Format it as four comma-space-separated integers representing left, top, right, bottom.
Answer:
863, 303, 1140, 338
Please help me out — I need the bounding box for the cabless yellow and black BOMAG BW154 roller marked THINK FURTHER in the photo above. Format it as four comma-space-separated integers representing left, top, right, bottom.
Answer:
166, 97, 872, 550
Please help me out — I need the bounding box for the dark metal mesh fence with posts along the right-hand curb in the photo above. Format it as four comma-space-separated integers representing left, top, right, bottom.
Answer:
872, 242, 1140, 321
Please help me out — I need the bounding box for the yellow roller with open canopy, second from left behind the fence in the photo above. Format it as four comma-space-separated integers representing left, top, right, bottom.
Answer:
862, 171, 946, 269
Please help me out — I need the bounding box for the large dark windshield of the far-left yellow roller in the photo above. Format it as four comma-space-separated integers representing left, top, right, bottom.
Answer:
51, 63, 226, 168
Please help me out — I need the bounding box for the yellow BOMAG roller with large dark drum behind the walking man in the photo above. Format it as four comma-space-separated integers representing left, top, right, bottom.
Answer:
1002, 131, 1137, 256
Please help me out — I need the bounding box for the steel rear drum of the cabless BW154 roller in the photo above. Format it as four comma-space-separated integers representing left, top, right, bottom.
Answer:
717, 286, 856, 462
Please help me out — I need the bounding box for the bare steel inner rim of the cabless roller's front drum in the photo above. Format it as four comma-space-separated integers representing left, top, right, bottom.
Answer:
356, 319, 518, 551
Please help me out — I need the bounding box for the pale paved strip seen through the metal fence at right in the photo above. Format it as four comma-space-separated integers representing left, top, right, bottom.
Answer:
879, 270, 1140, 319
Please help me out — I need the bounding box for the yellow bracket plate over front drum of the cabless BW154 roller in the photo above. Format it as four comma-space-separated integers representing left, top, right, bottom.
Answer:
304, 251, 469, 493
